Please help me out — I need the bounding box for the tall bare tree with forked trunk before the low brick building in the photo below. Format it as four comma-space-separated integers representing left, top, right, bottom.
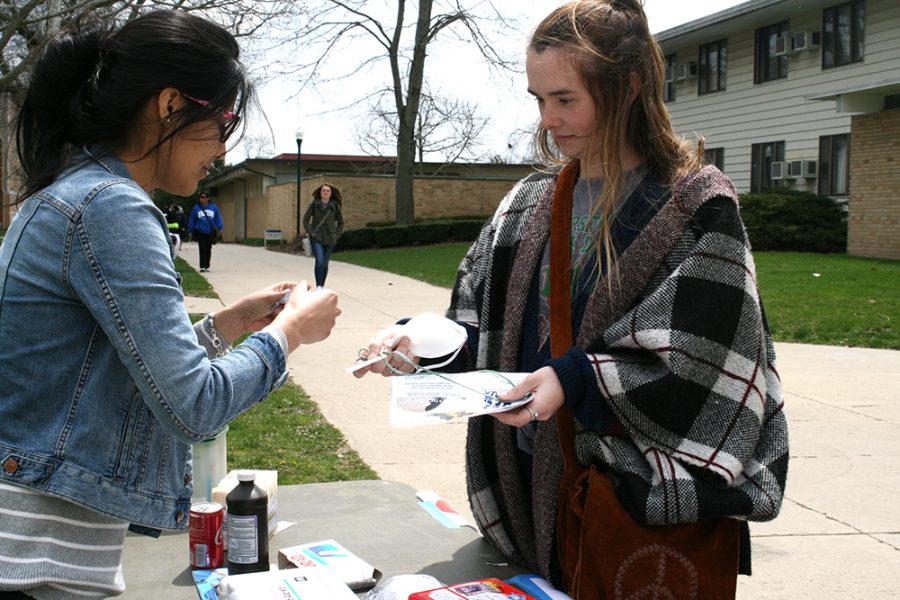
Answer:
282, 0, 516, 224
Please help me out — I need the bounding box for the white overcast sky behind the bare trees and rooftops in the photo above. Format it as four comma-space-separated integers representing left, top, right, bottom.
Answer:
232, 0, 745, 163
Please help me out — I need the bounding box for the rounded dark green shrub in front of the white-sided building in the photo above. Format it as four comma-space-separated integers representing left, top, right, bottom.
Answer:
740, 188, 847, 253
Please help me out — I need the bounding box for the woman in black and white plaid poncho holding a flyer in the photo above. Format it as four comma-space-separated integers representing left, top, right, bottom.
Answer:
358, 0, 788, 599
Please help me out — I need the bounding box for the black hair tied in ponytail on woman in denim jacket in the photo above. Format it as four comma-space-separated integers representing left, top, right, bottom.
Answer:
16, 10, 252, 198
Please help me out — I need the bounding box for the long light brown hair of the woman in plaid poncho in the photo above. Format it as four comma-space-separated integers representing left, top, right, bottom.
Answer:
529, 0, 703, 272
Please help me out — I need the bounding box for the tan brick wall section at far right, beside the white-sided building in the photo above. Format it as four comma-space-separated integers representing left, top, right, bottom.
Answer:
847, 110, 900, 260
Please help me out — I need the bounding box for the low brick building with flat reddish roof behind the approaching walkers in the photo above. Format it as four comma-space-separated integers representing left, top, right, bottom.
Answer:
201, 154, 533, 241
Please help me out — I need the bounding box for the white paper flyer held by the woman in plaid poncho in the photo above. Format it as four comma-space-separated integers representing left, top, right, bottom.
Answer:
390, 371, 531, 427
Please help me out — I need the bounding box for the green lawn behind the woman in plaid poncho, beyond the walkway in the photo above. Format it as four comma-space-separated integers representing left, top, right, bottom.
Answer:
334, 244, 900, 350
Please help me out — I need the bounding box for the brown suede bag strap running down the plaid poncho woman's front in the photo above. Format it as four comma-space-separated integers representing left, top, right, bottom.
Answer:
549, 160, 579, 471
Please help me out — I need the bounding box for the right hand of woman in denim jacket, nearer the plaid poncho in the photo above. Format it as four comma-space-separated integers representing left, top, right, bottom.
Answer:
272, 281, 341, 352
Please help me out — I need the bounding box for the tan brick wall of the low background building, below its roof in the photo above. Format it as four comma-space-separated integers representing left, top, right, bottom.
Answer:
237, 175, 517, 240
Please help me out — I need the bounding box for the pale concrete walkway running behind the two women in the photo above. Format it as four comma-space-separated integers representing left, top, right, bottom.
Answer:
180, 243, 900, 600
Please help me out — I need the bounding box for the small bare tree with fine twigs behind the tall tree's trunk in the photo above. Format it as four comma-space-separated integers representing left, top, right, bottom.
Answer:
356, 90, 488, 174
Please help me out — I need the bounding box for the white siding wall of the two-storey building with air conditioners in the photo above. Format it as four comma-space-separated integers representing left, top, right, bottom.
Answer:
662, 0, 900, 193
